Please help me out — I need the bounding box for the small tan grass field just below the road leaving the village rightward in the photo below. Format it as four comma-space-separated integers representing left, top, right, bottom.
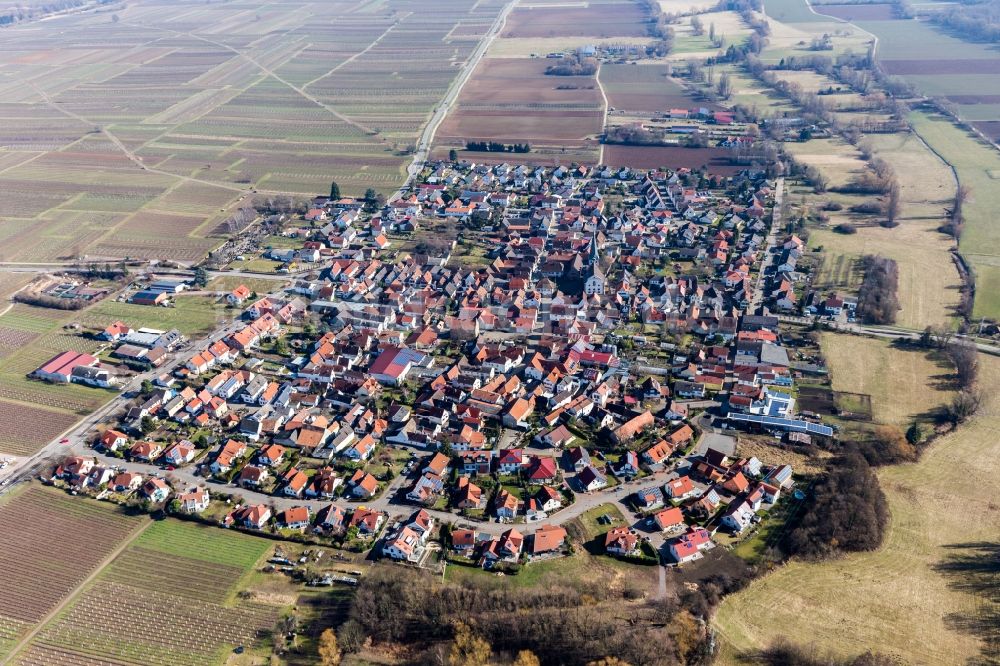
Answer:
822, 333, 953, 426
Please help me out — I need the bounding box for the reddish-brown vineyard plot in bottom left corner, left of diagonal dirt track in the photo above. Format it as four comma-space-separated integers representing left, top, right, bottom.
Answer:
0, 486, 148, 657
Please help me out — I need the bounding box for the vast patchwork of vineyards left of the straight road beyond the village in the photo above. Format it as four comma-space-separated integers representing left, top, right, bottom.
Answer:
0, 0, 504, 262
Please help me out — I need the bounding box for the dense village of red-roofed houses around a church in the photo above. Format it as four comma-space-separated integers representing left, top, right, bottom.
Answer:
39, 162, 834, 573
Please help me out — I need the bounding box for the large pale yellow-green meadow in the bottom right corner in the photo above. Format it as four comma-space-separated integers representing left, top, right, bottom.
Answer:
715, 352, 1000, 664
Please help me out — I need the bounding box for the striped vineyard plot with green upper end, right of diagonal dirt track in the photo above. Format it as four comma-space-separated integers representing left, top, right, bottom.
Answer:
0, 500, 285, 666
